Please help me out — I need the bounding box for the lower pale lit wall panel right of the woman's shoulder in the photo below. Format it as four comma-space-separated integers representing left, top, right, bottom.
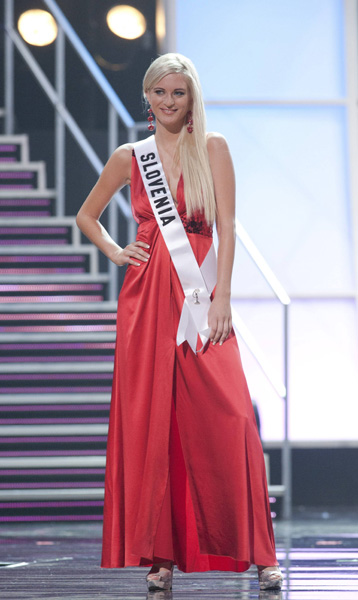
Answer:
207, 107, 354, 294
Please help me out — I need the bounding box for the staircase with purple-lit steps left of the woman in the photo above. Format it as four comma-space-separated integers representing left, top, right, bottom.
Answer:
0, 135, 116, 521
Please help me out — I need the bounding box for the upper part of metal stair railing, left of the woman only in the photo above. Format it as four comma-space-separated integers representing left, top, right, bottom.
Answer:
5, 0, 143, 300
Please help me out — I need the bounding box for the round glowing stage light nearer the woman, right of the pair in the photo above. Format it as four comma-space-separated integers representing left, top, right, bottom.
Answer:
107, 4, 147, 40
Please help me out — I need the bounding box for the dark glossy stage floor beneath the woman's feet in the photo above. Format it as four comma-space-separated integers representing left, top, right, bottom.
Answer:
0, 511, 358, 600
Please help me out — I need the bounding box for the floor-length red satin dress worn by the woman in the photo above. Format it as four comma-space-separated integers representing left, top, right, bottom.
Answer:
102, 151, 277, 572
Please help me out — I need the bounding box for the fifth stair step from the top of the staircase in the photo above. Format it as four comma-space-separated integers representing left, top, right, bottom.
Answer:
0, 245, 98, 276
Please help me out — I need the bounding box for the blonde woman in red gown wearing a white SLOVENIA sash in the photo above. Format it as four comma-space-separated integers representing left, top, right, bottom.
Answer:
77, 54, 282, 590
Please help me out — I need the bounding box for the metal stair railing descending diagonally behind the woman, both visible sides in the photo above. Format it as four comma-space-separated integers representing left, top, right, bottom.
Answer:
5, 0, 291, 519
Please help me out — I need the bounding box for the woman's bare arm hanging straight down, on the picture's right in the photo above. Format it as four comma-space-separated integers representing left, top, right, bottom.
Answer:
207, 133, 235, 345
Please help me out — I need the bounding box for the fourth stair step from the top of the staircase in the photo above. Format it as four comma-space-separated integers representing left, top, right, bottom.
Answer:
0, 217, 80, 247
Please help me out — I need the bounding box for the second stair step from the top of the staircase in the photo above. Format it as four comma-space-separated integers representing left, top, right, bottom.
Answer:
0, 161, 46, 190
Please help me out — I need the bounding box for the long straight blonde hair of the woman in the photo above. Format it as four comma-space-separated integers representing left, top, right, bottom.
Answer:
143, 53, 216, 224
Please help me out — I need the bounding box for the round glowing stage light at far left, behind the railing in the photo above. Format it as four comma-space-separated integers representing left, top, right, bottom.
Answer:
17, 9, 57, 46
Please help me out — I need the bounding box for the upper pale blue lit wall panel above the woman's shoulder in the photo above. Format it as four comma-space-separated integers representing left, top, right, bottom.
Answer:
176, 0, 345, 100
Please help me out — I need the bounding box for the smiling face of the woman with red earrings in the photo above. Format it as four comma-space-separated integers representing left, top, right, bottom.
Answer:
147, 73, 192, 133
